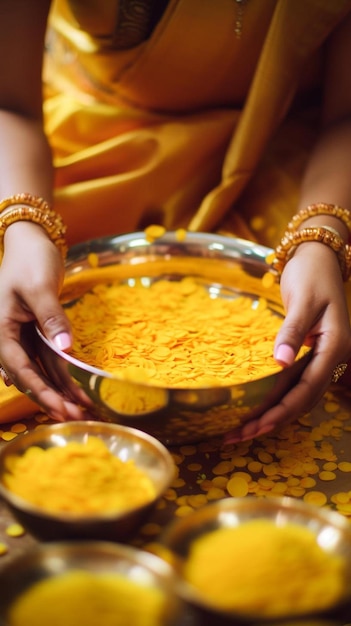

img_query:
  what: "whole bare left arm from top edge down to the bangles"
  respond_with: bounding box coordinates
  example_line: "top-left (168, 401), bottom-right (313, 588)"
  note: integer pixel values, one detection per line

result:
top-left (0, 0), bottom-right (53, 201)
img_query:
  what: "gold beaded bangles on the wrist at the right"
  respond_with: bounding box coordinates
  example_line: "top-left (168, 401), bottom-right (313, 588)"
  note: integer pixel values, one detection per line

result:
top-left (271, 203), bottom-right (351, 281)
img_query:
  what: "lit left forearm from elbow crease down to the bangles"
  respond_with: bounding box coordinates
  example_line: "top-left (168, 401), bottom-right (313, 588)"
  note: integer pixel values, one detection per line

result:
top-left (0, 110), bottom-right (53, 202)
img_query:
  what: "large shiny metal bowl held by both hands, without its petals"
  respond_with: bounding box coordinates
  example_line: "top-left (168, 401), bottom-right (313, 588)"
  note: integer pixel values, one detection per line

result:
top-left (37, 232), bottom-right (311, 445)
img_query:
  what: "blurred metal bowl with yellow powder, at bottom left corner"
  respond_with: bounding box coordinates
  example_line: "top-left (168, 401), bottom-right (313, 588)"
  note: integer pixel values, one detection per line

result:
top-left (0, 541), bottom-right (184, 626)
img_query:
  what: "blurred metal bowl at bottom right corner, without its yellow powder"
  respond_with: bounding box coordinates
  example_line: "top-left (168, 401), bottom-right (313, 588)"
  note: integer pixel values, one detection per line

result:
top-left (160, 496), bottom-right (351, 626)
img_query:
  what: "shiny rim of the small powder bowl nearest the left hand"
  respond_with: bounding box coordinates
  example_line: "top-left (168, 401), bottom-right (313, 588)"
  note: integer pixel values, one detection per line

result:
top-left (0, 420), bottom-right (176, 526)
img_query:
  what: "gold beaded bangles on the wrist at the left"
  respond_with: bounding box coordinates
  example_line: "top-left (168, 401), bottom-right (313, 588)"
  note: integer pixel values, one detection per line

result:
top-left (0, 193), bottom-right (67, 261)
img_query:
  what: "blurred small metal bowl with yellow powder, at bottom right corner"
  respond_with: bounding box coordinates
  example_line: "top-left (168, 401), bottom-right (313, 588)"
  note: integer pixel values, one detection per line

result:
top-left (161, 496), bottom-right (351, 626)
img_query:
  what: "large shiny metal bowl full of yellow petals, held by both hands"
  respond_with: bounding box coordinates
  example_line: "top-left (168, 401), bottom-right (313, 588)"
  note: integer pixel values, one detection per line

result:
top-left (37, 229), bottom-right (311, 445)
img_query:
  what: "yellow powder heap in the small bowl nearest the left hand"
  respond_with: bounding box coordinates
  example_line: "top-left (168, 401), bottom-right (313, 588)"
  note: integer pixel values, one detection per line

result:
top-left (4, 437), bottom-right (155, 515)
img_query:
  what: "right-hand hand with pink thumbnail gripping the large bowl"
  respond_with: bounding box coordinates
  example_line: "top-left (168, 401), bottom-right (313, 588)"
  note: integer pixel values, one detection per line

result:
top-left (225, 242), bottom-right (351, 443)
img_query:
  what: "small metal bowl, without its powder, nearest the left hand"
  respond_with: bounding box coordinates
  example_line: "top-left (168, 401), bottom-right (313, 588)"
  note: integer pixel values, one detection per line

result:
top-left (0, 421), bottom-right (175, 541)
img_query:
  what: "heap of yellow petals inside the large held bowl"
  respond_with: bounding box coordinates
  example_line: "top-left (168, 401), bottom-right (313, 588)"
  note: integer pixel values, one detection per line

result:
top-left (67, 278), bottom-right (288, 386)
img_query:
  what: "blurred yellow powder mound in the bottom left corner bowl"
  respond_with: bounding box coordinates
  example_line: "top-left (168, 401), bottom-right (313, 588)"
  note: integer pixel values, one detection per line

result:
top-left (7, 570), bottom-right (166, 626)
